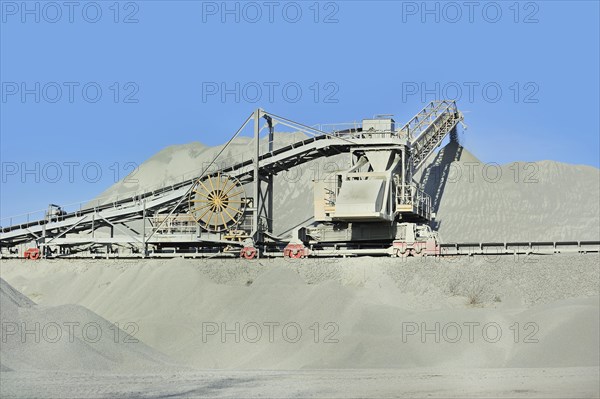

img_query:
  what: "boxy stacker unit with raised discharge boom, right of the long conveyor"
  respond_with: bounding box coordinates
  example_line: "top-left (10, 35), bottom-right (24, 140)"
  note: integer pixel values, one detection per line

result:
top-left (300, 109), bottom-right (450, 256)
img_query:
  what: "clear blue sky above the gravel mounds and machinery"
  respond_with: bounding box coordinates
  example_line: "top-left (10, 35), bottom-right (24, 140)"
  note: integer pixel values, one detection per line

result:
top-left (0, 0), bottom-right (600, 220)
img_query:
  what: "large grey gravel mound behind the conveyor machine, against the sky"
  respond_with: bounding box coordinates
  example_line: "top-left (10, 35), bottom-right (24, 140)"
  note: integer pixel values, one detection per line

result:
top-left (91, 133), bottom-right (600, 242)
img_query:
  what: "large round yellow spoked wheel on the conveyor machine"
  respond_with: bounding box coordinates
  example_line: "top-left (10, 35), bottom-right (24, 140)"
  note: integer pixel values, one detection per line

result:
top-left (190, 174), bottom-right (246, 233)
